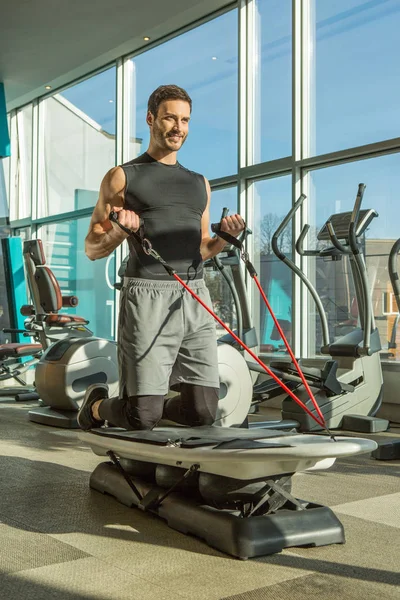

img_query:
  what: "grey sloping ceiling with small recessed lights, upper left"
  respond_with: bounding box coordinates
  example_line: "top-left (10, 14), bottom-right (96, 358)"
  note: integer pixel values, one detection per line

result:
top-left (0, 0), bottom-right (228, 110)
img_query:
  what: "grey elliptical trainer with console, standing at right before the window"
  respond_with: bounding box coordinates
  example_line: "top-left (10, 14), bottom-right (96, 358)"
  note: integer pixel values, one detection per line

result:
top-left (271, 184), bottom-right (389, 433)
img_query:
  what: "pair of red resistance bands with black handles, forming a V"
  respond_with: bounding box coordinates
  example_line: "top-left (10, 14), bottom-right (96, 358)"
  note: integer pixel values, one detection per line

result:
top-left (109, 212), bottom-right (330, 433)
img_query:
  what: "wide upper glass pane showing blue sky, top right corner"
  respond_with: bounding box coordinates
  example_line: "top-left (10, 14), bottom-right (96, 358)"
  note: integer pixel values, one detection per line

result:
top-left (310, 0), bottom-right (400, 155)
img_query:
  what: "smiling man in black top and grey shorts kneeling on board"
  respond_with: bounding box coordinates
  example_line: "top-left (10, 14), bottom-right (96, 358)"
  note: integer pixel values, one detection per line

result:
top-left (78, 85), bottom-right (244, 429)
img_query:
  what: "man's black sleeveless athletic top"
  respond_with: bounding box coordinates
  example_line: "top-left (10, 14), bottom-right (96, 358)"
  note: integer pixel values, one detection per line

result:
top-left (121, 152), bottom-right (207, 280)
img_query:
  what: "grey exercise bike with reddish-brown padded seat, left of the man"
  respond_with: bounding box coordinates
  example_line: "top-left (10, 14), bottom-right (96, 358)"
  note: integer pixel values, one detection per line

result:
top-left (23, 240), bottom-right (118, 428)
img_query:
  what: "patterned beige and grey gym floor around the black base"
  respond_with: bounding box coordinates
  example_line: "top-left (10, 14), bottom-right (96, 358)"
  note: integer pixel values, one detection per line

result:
top-left (0, 399), bottom-right (400, 600)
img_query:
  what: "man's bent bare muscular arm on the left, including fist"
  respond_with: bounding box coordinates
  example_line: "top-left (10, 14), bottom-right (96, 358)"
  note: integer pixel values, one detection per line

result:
top-left (85, 167), bottom-right (139, 260)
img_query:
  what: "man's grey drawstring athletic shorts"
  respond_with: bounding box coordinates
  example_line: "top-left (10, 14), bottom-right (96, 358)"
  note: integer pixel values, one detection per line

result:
top-left (118, 278), bottom-right (219, 396)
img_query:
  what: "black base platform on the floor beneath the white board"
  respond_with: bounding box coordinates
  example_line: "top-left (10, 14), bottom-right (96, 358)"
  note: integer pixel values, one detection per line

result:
top-left (90, 462), bottom-right (345, 560)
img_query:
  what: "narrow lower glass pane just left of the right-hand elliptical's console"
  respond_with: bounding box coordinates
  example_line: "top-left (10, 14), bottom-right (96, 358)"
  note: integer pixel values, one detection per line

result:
top-left (251, 175), bottom-right (292, 355)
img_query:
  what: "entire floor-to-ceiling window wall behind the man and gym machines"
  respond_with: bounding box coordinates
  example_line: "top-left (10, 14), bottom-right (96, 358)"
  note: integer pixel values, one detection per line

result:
top-left (5, 0), bottom-right (400, 360)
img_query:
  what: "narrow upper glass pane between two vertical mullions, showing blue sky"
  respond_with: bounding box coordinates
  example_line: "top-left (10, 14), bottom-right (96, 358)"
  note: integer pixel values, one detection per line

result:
top-left (255, 0), bottom-right (292, 164)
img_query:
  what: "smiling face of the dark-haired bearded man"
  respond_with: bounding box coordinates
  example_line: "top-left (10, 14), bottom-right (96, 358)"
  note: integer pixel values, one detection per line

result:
top-left (147, 100), bottom-right (190, 152)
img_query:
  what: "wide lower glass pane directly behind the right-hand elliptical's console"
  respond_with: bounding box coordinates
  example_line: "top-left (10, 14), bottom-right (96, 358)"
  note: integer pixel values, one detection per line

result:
top-left (309, 154), bottom-right (400, 360)
